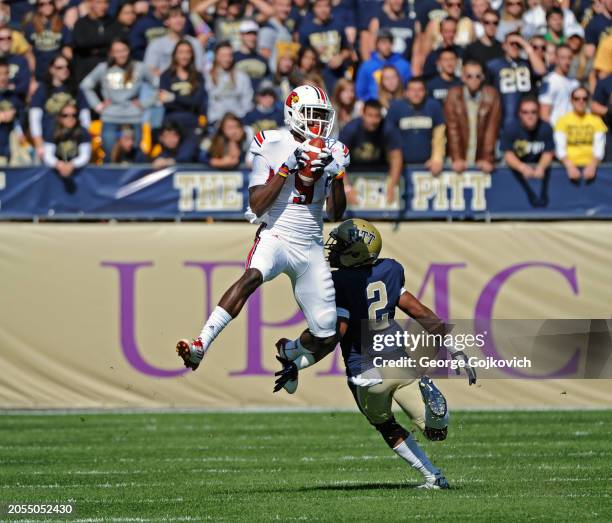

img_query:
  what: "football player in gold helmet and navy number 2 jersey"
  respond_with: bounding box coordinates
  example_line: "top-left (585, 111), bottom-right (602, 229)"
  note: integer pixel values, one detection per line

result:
top-left (274, 219), bottom-right (476, 489)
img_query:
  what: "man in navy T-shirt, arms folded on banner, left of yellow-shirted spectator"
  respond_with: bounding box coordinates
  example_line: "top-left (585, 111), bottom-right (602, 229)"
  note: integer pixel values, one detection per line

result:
top-left (501, 96), bottom-right (555, 178)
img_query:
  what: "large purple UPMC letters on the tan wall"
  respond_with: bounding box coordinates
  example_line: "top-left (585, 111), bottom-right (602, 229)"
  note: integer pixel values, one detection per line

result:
top-left (101, 260), bottom-right (586, 379)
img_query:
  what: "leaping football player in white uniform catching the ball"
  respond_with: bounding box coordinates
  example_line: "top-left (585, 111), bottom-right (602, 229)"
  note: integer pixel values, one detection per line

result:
top-left (176, 85), bottom-right (350, 392)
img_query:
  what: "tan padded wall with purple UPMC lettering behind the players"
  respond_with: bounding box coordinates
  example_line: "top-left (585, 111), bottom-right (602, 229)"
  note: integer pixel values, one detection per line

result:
top-left (0, 222), bottom-right (612, 408)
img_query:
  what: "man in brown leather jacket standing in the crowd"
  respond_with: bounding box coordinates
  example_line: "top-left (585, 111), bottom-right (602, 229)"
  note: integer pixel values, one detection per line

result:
top-left (444, 61), bottom-right (502, 173)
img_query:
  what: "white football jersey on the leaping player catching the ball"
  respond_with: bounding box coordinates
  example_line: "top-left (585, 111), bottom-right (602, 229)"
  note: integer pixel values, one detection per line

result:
top-left (246, 129), bottom-right (350, 240)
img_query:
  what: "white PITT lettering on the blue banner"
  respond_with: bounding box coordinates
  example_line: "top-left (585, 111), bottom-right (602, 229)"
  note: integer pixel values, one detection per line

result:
top-left (410, 171), bottom-right (491, 211)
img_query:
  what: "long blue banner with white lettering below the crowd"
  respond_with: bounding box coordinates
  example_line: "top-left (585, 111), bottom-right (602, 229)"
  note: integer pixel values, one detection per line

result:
top-left (0, 165), bottom-right (612, 220)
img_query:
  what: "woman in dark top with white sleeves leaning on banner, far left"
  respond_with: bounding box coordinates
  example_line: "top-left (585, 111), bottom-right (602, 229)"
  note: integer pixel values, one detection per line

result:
top-left (43, 101), bottom-right (91, 178)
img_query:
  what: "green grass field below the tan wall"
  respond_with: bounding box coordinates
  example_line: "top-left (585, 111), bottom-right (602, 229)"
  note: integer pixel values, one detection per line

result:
top-left (0, 411), bottom-right (612, 522)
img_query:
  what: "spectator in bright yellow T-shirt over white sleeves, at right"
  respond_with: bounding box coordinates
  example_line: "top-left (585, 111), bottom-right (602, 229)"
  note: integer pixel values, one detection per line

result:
top-left (555, 87), bottom-right (607, 181)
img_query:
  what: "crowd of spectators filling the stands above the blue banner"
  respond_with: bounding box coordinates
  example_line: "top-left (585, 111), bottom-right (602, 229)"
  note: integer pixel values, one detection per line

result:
top-left (0, 0), bottom-right (612, 194)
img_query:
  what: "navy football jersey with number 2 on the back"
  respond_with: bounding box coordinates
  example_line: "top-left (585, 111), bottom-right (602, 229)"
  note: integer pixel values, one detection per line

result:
top-left (332, 258), bottom-right (404, 376)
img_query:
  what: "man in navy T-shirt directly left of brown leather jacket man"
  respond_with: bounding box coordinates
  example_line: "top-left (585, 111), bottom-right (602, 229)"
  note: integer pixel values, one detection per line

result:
top-left (385, 78), bottom-right (445, 176)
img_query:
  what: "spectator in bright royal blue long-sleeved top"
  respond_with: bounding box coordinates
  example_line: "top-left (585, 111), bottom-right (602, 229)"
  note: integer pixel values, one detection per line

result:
top-left (355, 29), bottom-right (411, 100)
